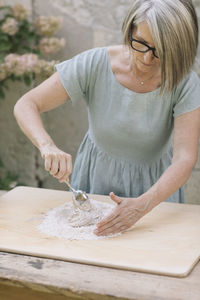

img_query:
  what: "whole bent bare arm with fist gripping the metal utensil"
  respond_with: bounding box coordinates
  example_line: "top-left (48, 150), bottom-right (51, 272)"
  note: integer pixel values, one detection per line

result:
top-left (14, 73), bottom-right (72, 182)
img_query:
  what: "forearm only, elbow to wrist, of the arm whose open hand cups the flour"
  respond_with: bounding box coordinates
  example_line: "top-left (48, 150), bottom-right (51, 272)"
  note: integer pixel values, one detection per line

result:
top-left (141, 160), bottom-right (194, 211)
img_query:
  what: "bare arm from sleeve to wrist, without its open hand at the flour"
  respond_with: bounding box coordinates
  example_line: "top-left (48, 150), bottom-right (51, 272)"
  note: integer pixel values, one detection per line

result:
top-left (143, 108), bottom-right (200, 207)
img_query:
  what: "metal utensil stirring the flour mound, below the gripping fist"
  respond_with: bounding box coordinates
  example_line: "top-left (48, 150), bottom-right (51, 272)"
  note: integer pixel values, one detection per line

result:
top-left (65, 181), bottom-right (91, 210)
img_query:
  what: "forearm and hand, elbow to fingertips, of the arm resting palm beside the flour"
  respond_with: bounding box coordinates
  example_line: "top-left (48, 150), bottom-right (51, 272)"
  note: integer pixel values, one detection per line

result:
top-left (94, 160), bottom-right (195, 235)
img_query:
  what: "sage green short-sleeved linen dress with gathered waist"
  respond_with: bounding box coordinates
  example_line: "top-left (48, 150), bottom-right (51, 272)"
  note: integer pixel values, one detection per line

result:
top-left (56, 47), bottom-right (200, 202)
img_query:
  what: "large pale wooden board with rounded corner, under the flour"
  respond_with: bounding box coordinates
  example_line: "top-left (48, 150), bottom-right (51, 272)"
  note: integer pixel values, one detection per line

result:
top-left (0, 187), bottom-right (200, 277)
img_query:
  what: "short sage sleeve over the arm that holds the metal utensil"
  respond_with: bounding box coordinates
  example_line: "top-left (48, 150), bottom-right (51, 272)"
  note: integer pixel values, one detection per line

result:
top-left (55, 48), bottom-right (100, 104)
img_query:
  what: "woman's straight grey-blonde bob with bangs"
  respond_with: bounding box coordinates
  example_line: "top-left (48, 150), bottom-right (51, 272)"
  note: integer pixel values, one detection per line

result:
top-left (122, 0), bottom-right (198, 93)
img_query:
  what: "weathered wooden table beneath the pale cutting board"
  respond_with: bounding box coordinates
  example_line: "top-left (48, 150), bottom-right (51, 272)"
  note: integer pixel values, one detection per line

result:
top-left (0, 252), bottom-right (200, 300)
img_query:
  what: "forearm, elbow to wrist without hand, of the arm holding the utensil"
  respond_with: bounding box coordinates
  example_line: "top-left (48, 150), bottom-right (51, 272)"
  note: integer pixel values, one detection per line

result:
top-left (14, 95), bottom-right (54, 149)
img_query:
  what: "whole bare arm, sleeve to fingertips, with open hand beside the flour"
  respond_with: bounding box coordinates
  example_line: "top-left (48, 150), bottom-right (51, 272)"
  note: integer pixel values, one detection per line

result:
top-left (95, 108), bottom-right (200, 235)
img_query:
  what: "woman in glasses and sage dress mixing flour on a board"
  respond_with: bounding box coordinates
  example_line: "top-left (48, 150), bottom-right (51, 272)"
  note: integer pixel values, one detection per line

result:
top-left (14, 0), bottom-right (200, 235)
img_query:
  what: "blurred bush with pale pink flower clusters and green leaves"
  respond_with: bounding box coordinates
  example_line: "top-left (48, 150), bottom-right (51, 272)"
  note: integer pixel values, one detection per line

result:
top-left (0, 4), bottom-right (65, 98)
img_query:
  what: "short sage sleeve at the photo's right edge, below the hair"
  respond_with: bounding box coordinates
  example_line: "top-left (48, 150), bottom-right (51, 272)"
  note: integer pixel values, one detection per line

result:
top-left (173, 71), bottom-right (200, 118)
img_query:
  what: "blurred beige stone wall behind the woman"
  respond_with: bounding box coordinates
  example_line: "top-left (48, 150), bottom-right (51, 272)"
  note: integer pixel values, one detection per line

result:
top-left (0, 0), bottom-right (200, 204)
